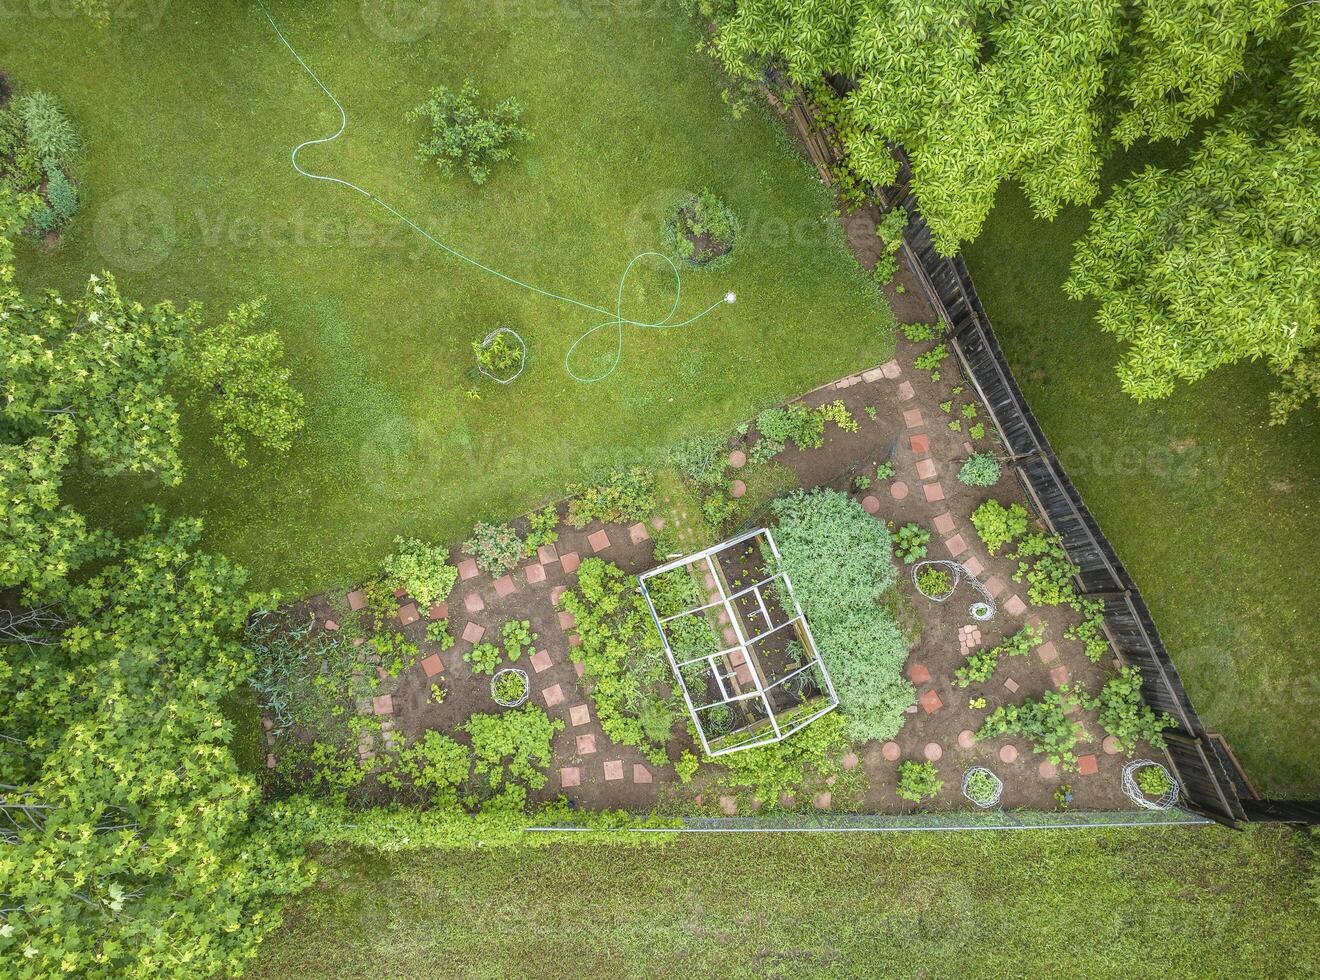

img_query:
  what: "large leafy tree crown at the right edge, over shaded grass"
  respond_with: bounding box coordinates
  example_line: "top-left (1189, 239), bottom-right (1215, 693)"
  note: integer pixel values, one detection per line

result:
top-left (1065, 5), bottom-right (1320, 423)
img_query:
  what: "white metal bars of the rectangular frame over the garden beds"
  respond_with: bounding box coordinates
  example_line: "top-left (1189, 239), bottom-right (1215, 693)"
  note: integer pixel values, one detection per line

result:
top-left (638, 528), bottom-right (838, 757)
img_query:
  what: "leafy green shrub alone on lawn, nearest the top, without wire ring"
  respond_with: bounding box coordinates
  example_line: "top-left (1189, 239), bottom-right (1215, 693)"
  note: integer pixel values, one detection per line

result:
top-left (408, 79), bottom-right (531, 184)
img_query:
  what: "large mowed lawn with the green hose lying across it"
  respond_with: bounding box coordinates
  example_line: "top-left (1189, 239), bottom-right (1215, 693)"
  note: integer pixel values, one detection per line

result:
top-left (0, 1), bottom-right (892, 593)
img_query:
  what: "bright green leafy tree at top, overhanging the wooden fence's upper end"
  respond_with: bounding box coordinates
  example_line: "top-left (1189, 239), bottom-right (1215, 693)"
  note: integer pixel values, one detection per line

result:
top-left (713, 0), bottom-right (1284, 254)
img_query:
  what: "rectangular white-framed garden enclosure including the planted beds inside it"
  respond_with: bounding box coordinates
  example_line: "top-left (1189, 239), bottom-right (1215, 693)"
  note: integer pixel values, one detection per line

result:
top-left (639, 527), bottom-right (838, 757)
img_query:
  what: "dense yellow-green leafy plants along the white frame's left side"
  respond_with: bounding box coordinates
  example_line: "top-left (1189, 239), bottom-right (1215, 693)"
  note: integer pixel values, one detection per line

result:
top-left (560, 557), bottom-right (681, 766)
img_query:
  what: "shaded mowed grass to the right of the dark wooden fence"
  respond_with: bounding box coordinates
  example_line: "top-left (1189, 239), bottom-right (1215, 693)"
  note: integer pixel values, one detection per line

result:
top-left (965, 180), bottom-right (1320, 796)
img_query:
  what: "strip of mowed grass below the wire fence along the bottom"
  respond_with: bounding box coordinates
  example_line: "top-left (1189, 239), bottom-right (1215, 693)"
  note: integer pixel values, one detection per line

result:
top-left (251, 828), bottom-right (1320, 980)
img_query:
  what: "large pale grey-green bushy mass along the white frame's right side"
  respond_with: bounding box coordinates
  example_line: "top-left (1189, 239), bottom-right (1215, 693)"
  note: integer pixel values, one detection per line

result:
top-left (772, 489), bottom-right (913, 741)
